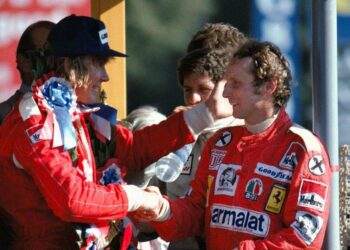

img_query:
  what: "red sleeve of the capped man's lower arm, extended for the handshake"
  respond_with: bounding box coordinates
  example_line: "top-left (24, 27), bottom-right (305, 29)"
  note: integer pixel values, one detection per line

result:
top-left (13, 116), bottom-right (128, 223)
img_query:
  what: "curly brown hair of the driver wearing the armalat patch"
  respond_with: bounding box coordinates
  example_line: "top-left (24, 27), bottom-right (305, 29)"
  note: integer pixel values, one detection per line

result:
top-left (234, 40), bottom-right (292, 108)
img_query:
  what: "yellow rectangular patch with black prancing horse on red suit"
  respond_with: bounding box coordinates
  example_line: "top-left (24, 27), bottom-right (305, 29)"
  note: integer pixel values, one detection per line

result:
top-left (265, 184), bottom-right (287, 214)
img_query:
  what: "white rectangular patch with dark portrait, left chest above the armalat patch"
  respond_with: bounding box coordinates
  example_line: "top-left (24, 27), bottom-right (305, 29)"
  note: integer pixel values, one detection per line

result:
top-left (214, 164), bottom-right (242, 196)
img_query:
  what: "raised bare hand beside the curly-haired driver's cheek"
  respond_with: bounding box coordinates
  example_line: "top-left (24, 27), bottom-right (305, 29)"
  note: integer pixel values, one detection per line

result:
top-left (205, 79), bottom-right (233, 120)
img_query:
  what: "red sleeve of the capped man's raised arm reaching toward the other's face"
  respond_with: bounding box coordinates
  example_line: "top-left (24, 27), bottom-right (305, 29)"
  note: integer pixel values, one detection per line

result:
top-left (113, 112), bottom-right (194, 170)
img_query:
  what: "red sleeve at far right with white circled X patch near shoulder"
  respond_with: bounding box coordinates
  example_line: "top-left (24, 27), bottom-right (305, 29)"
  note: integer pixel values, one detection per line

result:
top-left (239, 138), bottom-right (332, 250)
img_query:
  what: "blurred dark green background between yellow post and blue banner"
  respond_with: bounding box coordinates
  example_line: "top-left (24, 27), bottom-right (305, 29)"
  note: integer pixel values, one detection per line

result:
top-left (125, 0), bottom-right (249, 115)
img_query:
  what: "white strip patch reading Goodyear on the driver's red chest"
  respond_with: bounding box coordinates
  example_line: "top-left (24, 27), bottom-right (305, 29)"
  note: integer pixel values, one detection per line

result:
top-left (255, 162), bottom-right (293, 183)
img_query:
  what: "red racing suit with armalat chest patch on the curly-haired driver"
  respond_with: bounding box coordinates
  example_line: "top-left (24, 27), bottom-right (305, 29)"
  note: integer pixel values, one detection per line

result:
top-left (152, 109), bottom-right (331, 250)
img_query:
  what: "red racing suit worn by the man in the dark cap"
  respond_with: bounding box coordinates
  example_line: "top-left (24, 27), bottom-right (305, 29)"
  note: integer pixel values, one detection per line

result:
top-left (0, 77), bottom-right (194, 249)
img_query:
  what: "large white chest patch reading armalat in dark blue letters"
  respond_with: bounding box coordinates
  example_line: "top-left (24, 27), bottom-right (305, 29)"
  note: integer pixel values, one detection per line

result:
top-left (210, 204), bottom-right (270, 237)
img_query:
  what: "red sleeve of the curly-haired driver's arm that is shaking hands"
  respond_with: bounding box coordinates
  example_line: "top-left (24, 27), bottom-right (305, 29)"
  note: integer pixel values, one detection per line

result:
top-left (151, 138), bottom-right (210, 241)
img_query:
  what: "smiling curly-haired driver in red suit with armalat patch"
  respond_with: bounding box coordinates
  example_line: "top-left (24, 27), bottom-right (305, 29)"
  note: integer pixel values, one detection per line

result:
top-left (136, 41), bottom-right (331, 250)
